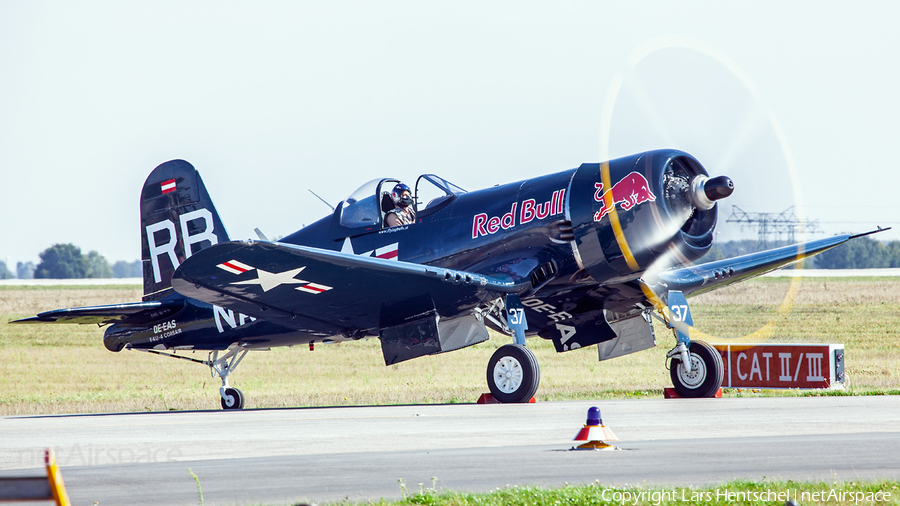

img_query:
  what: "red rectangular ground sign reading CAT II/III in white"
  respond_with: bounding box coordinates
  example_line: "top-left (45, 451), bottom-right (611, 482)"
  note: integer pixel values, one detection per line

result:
top-left (713, 344), bottom-right (844, 388)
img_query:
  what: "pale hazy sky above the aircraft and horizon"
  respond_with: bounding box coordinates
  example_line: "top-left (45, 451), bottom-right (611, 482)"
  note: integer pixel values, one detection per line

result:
top-left (0, 0), bottom-right (900, 267)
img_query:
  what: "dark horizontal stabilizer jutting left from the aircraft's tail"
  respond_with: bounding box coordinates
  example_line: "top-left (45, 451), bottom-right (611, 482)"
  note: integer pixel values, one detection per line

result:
top-left (10, 301), bottom-right (183, 324)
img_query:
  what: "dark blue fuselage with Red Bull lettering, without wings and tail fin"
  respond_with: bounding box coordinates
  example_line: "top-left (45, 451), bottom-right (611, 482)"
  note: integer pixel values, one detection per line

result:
top-left (106, 150), bottom-right (715, 349)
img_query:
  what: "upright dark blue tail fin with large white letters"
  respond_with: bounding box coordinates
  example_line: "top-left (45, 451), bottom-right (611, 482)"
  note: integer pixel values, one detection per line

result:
top-left (141, 160), bottom-right (228, 300)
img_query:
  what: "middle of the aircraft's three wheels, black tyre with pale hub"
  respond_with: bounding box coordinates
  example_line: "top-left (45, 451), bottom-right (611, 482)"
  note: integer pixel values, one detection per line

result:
top-left (487, 344), bottom-right (541, 403)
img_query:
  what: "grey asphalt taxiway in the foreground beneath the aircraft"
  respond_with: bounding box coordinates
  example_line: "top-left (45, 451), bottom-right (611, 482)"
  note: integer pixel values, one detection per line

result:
top-left (0, 396), bottom-right (900, 505)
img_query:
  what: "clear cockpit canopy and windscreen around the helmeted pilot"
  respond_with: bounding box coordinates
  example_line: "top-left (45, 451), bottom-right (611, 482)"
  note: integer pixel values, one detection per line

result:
top-left (340, 174), bottom-right (466, 229)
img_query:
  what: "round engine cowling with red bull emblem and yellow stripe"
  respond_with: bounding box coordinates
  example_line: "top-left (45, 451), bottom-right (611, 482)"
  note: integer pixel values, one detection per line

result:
top-left (568, 150), bottom-right (734, 283)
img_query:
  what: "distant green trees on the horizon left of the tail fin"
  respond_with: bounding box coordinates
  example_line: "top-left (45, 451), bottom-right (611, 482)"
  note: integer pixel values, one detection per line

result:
top-left (0, 244), bottom-right (143, 279)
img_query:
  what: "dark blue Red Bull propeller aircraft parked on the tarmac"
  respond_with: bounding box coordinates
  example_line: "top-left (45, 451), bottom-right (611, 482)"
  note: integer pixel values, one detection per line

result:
top-left (15, 150), bottom-right (880, 409)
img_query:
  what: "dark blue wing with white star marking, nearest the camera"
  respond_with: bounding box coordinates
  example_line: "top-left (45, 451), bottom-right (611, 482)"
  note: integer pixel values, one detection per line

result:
top-left (172, 241), bottom-right (521, 335)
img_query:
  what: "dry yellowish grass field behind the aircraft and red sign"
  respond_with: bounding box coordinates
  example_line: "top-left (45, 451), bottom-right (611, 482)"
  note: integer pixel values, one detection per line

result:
top-left (0, 278), bottom-right (900, 415)
